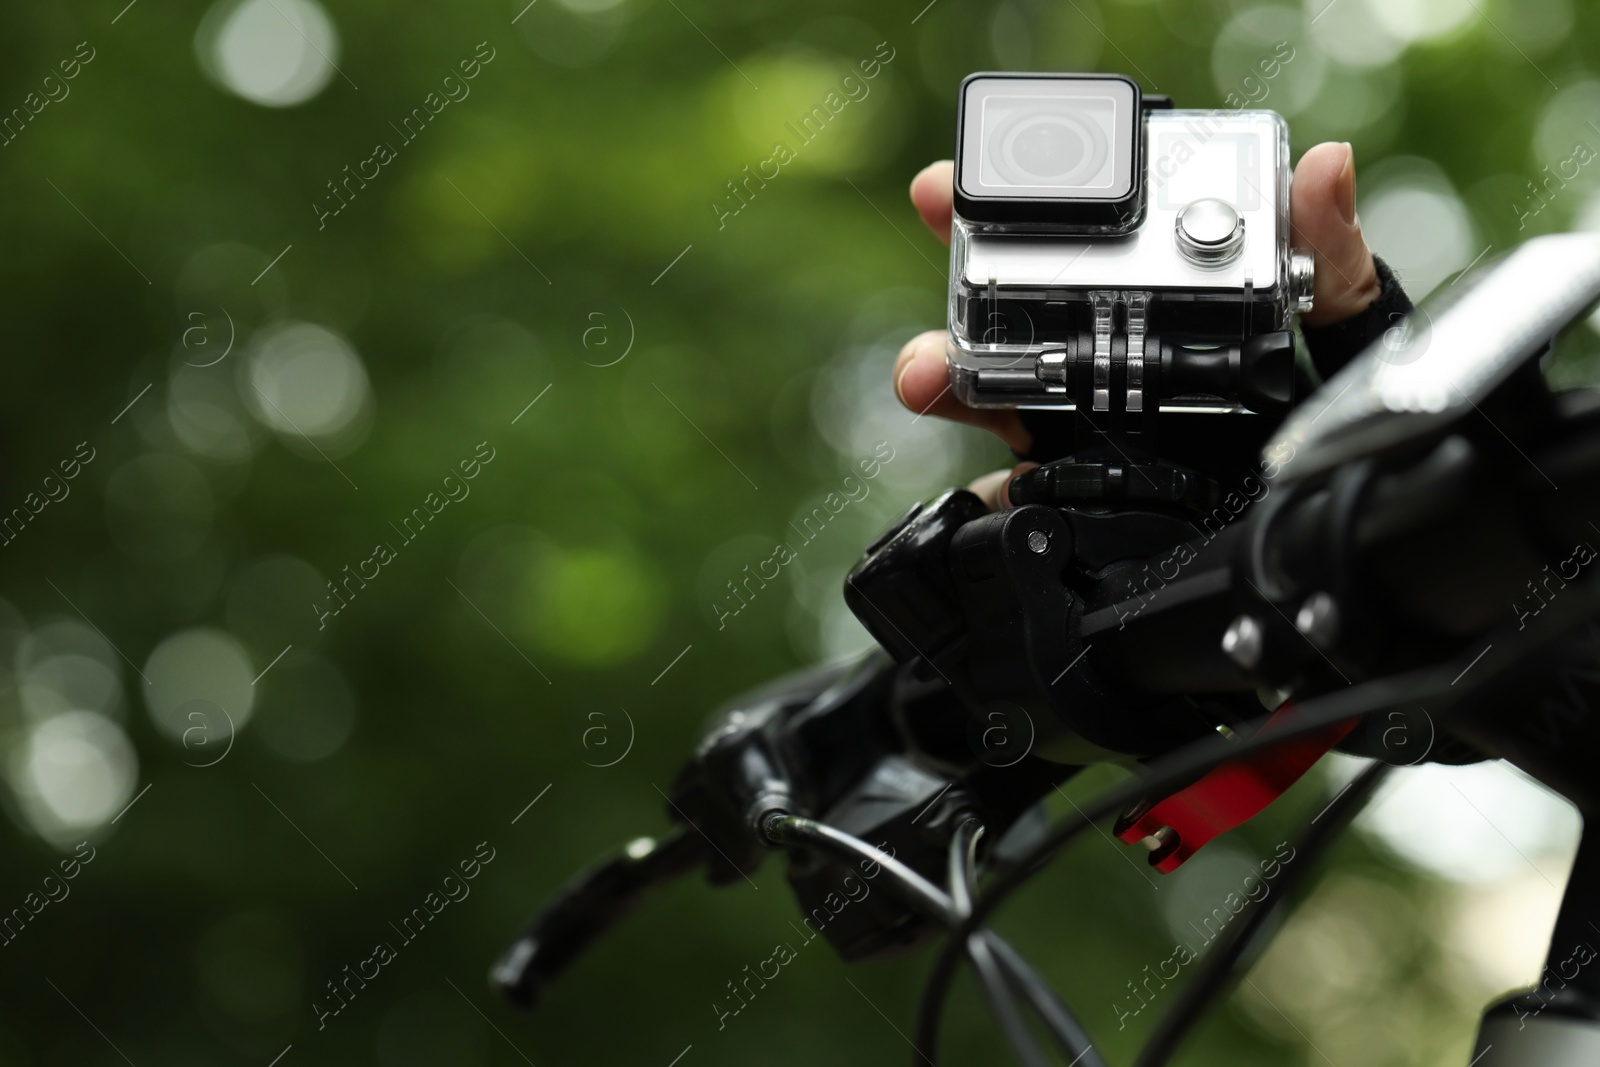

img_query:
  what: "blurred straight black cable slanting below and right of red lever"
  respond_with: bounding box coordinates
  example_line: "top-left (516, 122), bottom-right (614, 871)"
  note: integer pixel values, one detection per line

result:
top-left (1134, 763), bottom-right (1394, 1067)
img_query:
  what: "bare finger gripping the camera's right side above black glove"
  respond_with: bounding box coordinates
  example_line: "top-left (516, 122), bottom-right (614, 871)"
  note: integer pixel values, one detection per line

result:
top-left (1290, 142), bottom-right (1379, 326)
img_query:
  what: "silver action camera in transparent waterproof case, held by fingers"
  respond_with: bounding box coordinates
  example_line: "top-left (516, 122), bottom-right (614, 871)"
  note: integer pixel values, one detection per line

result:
top-left (949, 74), bottom-right (1314, 413)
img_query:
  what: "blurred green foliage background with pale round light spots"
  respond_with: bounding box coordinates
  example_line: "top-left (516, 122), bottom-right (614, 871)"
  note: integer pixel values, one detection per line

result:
top-left (0, 0), bottom-right (1600, 1067)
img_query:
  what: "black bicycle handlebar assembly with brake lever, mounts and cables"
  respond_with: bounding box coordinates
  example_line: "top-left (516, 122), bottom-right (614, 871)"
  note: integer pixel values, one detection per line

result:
top-left (493, 238), bottom-right (1600, 1062)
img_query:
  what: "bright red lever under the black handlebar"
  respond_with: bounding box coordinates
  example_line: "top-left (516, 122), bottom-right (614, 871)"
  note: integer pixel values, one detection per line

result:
top-left (1115, 702), bottom-right (1357, 875)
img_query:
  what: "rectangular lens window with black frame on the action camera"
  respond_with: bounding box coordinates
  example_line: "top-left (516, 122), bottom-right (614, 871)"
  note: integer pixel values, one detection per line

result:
top-left (960, 77), bottom-right (1138, 200)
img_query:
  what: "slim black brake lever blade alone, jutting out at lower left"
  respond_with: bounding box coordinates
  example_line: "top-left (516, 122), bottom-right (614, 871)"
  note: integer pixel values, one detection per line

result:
top-left (490, 827), bottom-right (707, 1011)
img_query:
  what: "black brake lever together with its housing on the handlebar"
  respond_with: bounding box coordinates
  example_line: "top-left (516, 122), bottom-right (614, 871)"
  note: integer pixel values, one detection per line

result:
top-left (490, 654), bottom-right (1075, 1009)
